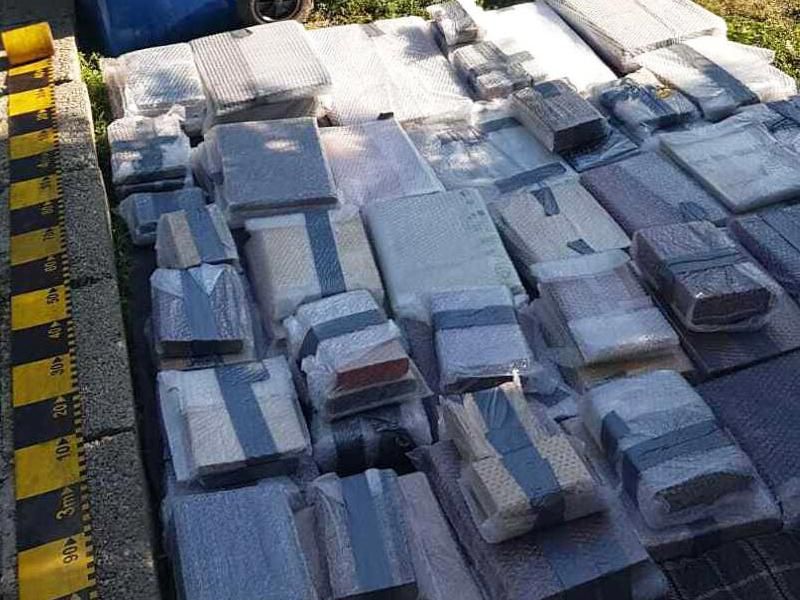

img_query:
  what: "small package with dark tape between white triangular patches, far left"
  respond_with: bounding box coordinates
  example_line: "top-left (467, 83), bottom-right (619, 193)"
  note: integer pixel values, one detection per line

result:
top-left (150, 264), bottom-right (244, 358)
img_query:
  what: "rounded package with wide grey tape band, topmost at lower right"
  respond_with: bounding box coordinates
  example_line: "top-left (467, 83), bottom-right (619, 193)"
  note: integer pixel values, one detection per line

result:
top-left (580, 371), bottom-right (768, 529)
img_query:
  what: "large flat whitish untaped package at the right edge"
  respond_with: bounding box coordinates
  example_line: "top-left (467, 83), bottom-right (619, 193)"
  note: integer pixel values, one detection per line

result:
top-left (661, 122), bottom-right (800, 213)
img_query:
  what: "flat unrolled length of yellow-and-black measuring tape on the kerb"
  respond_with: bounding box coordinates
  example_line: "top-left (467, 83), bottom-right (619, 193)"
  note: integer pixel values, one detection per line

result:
top-left (7, 58), bottom-right (97, 600)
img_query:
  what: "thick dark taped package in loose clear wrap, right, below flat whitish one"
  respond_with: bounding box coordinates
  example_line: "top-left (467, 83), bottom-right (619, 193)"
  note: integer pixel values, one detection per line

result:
top-left (632, 222), bottom-right (780, 332)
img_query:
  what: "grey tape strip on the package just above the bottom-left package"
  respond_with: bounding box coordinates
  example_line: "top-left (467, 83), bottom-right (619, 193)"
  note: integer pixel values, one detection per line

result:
top-left (215, 365), bottom-right (278, 459)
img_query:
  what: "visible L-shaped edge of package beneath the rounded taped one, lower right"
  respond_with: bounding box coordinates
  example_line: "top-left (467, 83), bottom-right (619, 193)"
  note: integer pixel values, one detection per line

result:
top-left (561, 419), bottom-right (782, 562)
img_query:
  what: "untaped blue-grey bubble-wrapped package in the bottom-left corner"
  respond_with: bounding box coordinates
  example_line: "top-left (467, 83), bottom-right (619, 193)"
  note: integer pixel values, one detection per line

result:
top-left (169, 484), bottom-right (319, 600)
